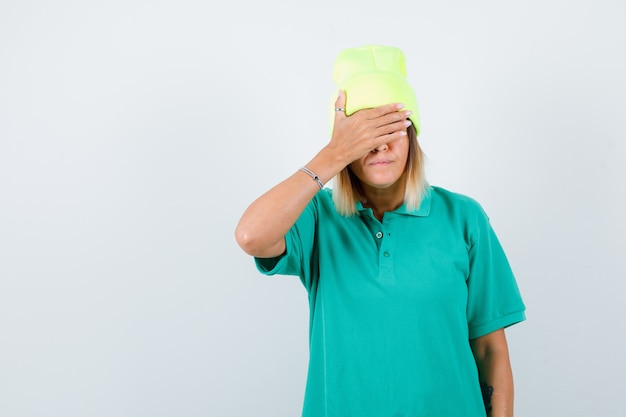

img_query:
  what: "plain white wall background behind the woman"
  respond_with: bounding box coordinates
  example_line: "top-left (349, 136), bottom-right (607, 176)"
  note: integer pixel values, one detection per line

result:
top-left (0, 0), bottom-right (626, 417)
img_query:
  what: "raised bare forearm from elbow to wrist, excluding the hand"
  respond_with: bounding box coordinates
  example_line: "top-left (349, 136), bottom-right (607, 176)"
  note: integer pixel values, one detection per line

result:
top-left (235, 146), bottom-right (346, 258)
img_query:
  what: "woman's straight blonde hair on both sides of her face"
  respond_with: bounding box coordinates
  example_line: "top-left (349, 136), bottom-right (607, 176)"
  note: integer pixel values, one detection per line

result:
top-left (333, 126), bottom-right (427, 216)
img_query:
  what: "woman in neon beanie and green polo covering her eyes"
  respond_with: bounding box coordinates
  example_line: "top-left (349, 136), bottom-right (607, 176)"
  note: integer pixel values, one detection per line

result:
top-left (236, 45), bottom-right (525, 417)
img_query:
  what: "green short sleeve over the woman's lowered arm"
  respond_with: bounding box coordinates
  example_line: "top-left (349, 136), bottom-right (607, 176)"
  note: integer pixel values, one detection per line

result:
top-left (467, 207), bottom-right (526, 339)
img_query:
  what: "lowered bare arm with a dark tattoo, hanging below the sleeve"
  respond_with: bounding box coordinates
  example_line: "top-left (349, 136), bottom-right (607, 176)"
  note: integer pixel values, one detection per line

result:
top-left (472, 330), bottom-right (514, 417)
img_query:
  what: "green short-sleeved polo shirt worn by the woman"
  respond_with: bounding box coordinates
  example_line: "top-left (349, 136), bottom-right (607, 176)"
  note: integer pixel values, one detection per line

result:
top-left (256, 187), bottom-right (525, 417)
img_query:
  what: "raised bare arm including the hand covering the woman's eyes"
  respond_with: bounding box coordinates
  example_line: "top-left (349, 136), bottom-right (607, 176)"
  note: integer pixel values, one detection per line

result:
top-left (235, 92), bottom-right (410, 258)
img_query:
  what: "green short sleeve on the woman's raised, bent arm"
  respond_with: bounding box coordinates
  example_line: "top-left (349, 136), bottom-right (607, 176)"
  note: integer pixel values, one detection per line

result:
top-left (254, 191), bottom-right (318, 290)
